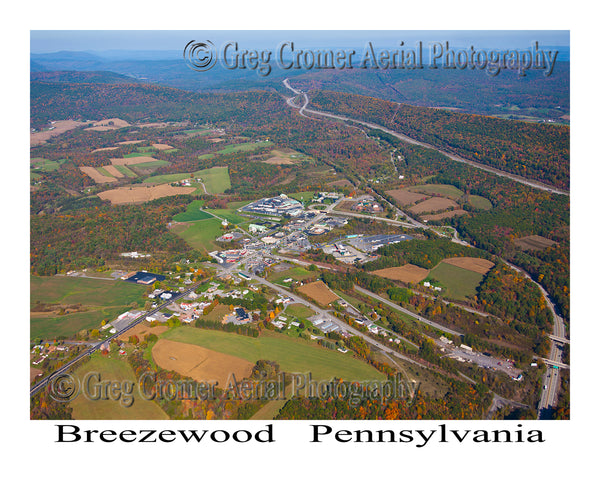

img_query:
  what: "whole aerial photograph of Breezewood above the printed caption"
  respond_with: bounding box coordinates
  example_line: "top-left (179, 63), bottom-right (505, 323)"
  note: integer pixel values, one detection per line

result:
top-left (29, 30), bottom-right (572, 424)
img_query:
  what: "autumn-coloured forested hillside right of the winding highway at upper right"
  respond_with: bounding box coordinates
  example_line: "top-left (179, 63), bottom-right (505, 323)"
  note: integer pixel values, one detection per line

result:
top-left (311, 91), bottom-right (570, 189)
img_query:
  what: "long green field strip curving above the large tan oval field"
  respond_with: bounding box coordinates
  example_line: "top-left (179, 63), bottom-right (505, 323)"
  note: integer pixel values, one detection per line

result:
top-left (161, 327), bottom-right (385, 381)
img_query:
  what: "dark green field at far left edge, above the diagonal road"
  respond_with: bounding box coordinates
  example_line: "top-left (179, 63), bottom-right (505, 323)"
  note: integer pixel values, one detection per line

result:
top-left (30, 276), bottom-right (146, 338)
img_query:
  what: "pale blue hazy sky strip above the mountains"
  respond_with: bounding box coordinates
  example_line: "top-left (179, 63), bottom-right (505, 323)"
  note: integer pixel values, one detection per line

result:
top-left (31, 30), bottom-right (570, 53)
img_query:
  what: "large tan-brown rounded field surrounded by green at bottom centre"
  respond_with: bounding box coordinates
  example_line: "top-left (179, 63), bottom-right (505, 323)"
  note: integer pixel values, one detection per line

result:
top-left (152, 338), bottom-right (253, 385)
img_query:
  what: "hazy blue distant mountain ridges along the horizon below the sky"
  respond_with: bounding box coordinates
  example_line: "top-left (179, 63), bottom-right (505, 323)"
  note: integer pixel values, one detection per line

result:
top-left (30, 51), bottom-right (570, 123)
